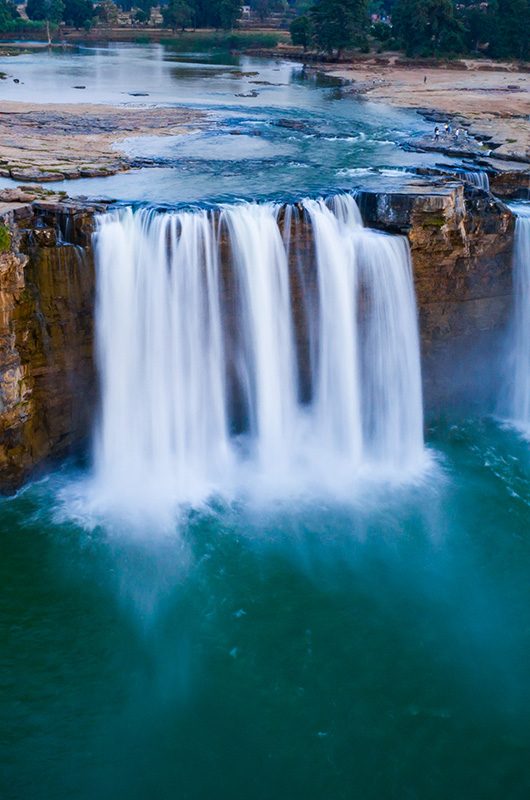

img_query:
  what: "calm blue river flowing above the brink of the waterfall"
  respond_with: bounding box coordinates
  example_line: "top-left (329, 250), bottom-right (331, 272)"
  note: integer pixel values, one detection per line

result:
top-left (0, 44), bottom-right (460, 204)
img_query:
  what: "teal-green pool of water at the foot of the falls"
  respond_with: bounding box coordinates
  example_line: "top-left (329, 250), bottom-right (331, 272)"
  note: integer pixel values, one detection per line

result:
top-left (0, 420), bottom-right (530, 800)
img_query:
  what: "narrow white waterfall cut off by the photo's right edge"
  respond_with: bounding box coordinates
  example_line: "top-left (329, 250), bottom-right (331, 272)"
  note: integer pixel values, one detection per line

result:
top-left (511, 204), bottom-right (530, 434)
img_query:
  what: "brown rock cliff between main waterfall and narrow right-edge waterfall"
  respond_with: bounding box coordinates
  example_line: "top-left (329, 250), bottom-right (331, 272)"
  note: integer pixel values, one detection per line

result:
top-left (361, 182), bottom-right (514, 409)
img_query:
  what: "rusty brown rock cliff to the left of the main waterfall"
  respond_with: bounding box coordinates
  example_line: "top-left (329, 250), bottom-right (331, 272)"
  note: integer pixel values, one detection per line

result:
top-left (0, 203), bottom-right (95, 490)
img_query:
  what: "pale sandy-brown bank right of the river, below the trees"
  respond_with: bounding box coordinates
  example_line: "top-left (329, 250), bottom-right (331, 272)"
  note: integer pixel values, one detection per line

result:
top-left (319, 56), bottom-right (530, 162)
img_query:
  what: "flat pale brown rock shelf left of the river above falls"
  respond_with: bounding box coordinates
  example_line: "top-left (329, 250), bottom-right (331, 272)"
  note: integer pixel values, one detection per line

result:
top-left (0, 102), bottom-right (206, 181)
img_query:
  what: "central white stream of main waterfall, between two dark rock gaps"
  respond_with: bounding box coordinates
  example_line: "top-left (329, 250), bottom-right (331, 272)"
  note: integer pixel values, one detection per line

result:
top-left (221, 204), bottom-right (296, 469)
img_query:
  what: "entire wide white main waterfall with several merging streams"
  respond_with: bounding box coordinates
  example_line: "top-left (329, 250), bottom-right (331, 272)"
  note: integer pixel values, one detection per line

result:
top-left (95, 195), bottom-right (424, 507)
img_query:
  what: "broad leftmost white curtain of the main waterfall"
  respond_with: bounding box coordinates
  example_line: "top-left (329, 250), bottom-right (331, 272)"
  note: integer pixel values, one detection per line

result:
top-left (96, 210), bottom-right (230, 500)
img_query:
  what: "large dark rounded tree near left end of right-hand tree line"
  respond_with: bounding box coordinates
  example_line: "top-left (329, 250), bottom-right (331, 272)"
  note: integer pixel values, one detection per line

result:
top-left (310, 0), bottom-right (368, 56)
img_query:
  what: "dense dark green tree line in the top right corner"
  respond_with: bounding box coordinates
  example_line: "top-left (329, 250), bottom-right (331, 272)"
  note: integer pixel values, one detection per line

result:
top-left (291, 0), bottom-right (530, 60)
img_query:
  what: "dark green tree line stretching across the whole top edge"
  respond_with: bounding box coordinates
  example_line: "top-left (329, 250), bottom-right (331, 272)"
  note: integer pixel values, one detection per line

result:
top-left (0, 0), bottom-right (530, 60)
